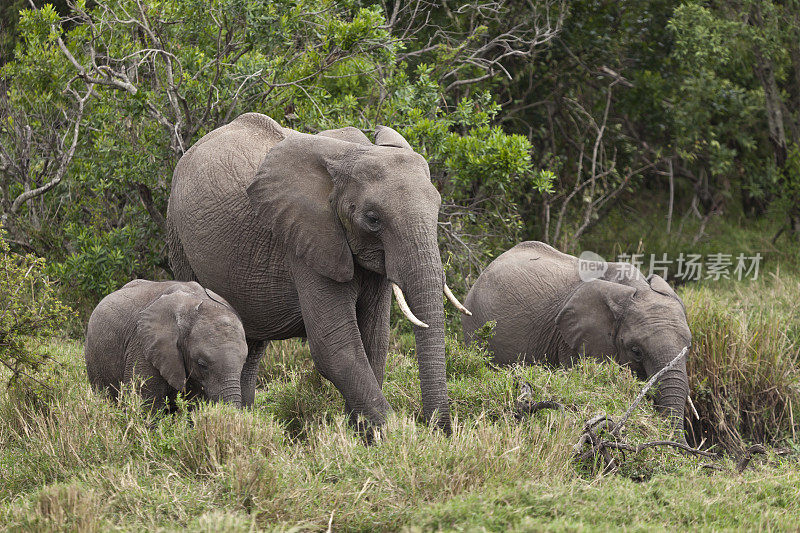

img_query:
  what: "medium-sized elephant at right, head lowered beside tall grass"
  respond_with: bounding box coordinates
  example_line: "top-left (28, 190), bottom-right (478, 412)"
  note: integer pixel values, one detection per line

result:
top-left (462, 241), bottom-right (692, 436)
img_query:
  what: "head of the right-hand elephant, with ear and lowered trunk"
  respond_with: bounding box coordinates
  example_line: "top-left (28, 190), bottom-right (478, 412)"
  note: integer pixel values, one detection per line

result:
top-left (556, 275), bottom-right (692, 436)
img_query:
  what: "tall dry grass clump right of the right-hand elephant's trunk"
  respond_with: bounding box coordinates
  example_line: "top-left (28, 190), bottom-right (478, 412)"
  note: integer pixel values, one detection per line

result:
top-left (682, 282), bottom-right (800, 452)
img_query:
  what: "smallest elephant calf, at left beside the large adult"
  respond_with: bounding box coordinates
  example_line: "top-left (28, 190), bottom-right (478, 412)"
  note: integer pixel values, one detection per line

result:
top-left (85, 279), bottom-right (247, 408)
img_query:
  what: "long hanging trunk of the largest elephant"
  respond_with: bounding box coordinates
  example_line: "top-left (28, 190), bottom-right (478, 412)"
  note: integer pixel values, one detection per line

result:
top-left (391, 232), bottom-right (452, 434)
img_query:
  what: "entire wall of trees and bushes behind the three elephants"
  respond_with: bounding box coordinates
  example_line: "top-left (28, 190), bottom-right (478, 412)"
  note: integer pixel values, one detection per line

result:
top-left (0, 0), bottom-right (800, 308)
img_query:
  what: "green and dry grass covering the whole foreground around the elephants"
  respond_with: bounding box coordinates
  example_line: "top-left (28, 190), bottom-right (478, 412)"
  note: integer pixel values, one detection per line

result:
top-left (0, 266), bottom-right (800, 531)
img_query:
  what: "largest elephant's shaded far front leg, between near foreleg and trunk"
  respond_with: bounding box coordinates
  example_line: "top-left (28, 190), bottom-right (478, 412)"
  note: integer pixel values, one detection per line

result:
top-left (356, 272), bottom-right (392, 387)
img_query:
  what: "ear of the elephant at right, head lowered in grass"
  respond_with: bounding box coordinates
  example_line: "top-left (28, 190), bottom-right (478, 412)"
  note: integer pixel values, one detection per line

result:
top-left (556, 279), bottom-right (636, 356)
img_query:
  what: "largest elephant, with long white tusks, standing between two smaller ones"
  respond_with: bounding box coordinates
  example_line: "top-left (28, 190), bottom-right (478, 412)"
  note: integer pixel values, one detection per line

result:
top-left (167, 113), bottom-right (450, 431)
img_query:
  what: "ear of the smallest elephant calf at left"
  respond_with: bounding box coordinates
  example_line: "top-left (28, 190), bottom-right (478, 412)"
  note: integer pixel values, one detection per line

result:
top-left (137, 291), bottom-right (202, 390)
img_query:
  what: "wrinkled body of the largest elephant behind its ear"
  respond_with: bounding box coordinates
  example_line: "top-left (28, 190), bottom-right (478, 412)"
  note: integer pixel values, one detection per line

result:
top-left (167, 113), bottom-right (302, 337)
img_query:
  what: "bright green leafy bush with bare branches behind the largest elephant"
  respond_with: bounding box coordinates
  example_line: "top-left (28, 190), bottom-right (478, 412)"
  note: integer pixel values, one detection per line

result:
top-left (0, 0), bottom-right (548, 309)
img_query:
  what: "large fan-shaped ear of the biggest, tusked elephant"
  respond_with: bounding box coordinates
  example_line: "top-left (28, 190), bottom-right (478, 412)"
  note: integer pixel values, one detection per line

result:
top-left (247, 133), bottom-right (356, 282)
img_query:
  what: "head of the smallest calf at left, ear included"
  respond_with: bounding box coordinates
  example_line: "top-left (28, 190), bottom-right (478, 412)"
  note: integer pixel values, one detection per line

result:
top-left (137, 290), bottom-right (247, 407)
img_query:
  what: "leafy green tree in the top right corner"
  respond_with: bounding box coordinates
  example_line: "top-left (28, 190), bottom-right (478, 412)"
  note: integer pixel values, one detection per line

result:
top-left (670, 0), bottom-right (800, 234)
